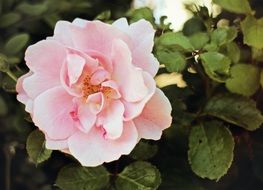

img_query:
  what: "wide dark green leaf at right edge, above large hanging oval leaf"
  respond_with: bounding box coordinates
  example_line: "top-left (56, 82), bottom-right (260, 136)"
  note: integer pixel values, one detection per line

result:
top-left (204, 94), bottom-right (263, 131)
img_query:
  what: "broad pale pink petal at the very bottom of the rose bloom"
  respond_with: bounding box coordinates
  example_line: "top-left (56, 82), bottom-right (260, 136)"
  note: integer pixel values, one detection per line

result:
top-left (68, 122), bottom-right (138, 166)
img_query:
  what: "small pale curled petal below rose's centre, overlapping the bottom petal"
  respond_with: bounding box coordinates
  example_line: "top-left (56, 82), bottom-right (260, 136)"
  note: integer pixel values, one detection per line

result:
top-left (97, 100), bottom-right (124, 139)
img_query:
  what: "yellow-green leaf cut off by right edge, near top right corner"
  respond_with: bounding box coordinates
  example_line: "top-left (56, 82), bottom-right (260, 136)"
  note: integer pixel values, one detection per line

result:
top-left (241, 16), bottom-right (263, 49)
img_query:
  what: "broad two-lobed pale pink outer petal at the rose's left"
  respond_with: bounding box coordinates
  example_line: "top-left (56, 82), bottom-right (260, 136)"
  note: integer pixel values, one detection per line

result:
top-left (22, 40), bottom-right (66, 99)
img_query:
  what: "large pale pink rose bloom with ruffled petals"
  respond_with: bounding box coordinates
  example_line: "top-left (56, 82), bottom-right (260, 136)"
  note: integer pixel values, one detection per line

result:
top-left (16, 18), bottom-right (172, 166)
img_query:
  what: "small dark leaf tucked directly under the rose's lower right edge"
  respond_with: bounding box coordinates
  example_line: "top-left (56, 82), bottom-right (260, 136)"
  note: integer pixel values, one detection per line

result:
top-left (130, 141), bottom-right (158, 160)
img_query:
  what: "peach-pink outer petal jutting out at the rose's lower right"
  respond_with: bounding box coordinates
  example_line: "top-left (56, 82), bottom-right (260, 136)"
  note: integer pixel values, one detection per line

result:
top-left (133, 88), bottom-right (172, 140)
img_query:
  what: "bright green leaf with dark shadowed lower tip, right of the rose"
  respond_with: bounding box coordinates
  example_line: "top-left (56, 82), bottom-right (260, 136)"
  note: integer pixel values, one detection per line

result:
top-left (200, 52), bottom-right (231, 82)
